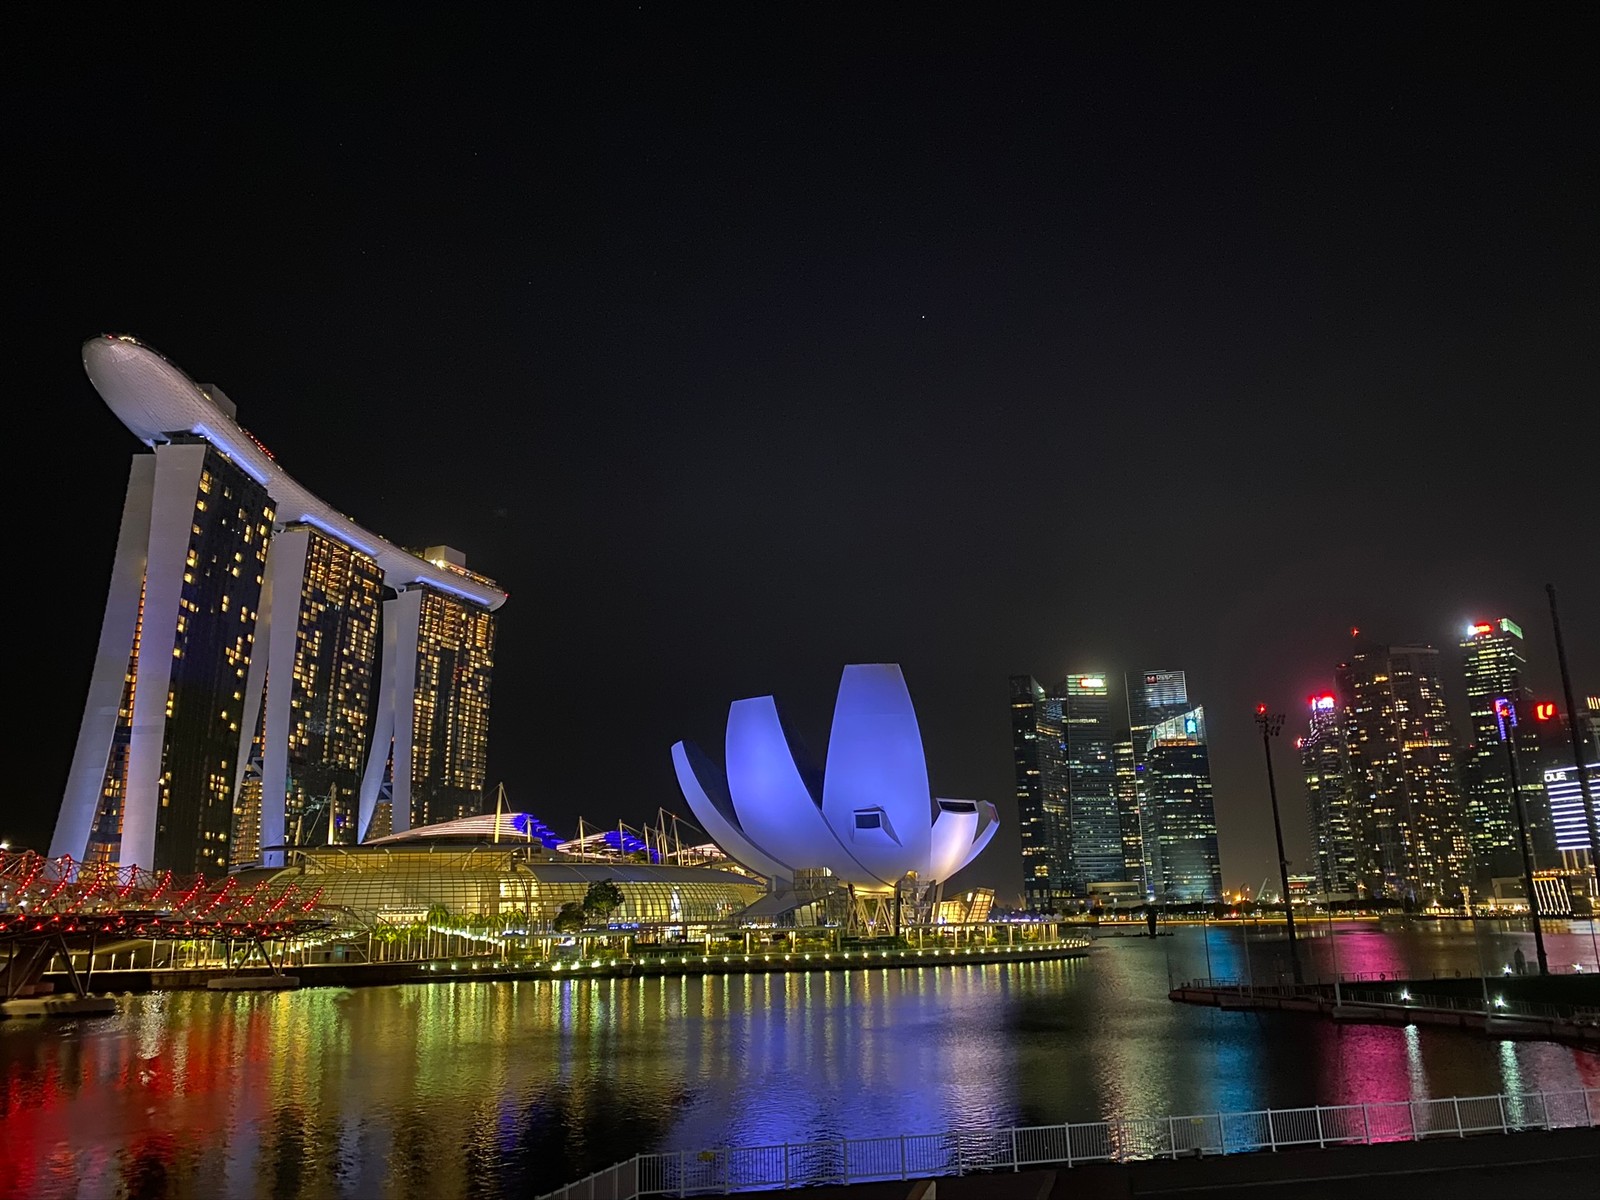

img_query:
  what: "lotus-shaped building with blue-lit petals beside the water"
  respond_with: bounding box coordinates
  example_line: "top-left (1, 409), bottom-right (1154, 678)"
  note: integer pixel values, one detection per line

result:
top-left (672, 662), bottom-right (1000, 891)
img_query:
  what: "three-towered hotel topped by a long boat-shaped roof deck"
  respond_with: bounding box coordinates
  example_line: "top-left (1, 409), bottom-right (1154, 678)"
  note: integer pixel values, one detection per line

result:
top-left (50, 336), bottom-right (506, 874)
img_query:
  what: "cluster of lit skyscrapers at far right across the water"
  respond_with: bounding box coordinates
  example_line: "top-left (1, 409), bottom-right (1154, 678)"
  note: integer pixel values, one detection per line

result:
top-left (1294, 616), bottom-right (1600, 912)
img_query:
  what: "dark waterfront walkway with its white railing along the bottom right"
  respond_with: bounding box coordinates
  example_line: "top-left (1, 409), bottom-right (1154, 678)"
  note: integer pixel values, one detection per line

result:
top-left (546, 1088), bottom-right (1600, 1200)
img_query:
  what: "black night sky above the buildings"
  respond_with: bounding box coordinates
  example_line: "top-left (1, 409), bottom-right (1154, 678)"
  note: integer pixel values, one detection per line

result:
top-left (0, 5), bottom-right (1600, 896)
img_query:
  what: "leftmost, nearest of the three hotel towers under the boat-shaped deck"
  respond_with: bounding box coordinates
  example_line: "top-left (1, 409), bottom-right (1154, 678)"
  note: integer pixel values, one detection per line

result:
top-left (53, 432), bottom-right (274, 872)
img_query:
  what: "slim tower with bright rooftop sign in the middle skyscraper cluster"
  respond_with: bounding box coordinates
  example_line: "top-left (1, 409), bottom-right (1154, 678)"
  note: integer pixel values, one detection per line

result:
top-left (1059, 672), bottom-right (1126, 896)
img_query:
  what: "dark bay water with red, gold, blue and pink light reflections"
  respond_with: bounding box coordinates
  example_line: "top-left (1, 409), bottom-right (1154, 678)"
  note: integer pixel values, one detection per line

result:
top-left (0, 923), bottom-right (1600, 1200)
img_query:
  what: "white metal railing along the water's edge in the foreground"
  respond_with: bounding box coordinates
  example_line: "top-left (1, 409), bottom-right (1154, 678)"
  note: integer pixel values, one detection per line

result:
top-left (546, 1088), bottom-right (1600, 1200)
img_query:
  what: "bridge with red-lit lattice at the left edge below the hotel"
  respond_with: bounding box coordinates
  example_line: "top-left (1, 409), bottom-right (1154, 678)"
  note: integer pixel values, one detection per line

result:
top-left (0, 850), bottom-right (334, 1000)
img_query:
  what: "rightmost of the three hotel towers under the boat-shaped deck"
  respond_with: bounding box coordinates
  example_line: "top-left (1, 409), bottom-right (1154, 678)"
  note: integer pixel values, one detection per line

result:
top-left (360, 546), bottom-right (494, 832)
